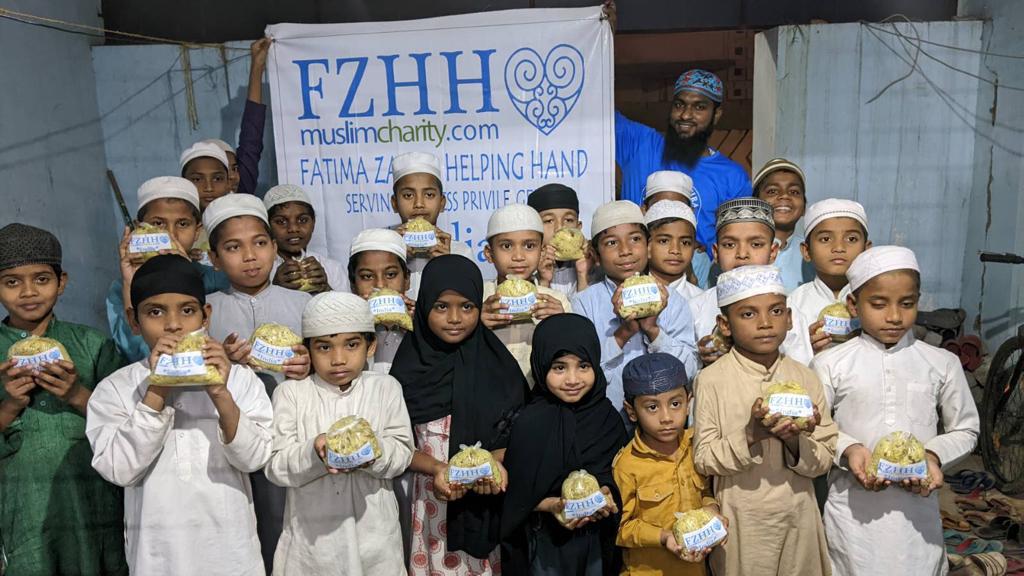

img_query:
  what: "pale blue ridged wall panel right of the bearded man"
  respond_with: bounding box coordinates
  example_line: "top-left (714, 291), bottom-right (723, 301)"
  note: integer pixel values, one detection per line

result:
top-left (754, 22), bottom-right (983, 310)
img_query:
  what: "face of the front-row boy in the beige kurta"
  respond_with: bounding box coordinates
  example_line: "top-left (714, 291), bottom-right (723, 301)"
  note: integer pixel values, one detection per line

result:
top-left (718, 294), bottom-right (793, 356)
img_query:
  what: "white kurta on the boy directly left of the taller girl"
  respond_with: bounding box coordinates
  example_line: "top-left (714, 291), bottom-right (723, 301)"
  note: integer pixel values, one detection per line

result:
top-left (266, 372), bottom-right (414, 576)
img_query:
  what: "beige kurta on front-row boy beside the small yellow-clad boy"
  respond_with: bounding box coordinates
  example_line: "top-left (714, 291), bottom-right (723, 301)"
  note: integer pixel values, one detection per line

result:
top-left (693, 348), bottom-right (839, 576)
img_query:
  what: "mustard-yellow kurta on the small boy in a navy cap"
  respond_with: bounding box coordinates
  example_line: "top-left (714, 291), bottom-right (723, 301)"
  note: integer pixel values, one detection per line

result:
top-left (612, 429), bottom-right (715, 576)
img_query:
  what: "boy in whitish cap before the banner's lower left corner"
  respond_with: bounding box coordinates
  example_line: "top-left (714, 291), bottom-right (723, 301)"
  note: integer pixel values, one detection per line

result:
top-left (263, 184), bottom-right (348, 294)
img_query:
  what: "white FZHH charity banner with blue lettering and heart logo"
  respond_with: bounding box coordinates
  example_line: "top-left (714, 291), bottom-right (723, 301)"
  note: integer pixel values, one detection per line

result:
top-left (266, 7), bottom-right (614, 275)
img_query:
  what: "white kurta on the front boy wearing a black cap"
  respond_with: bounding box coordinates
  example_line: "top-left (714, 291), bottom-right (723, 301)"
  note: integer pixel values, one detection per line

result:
top-left (86, 360), bottom-right (272, 576)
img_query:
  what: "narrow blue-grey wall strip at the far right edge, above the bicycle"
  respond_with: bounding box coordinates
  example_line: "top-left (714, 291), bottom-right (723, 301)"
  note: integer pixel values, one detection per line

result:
top-left (958, 0), bottom-right (1024, 342)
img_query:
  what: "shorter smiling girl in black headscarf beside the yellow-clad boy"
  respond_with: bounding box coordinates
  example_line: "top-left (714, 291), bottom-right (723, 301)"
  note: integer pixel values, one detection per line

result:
top-left (501, 314), bottom-right (627, 576)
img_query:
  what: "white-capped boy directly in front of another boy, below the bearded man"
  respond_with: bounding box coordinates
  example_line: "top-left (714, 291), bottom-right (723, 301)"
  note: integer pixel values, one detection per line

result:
top-left (643, 200), bottom-right (702, 301)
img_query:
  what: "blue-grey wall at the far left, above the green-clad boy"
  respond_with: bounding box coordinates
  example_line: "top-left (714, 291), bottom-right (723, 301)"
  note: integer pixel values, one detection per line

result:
top-left (0, 0), bottom-right (118, 330)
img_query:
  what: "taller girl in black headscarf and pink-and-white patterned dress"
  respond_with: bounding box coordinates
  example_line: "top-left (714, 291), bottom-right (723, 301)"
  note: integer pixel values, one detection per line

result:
top-left (391, 255), bottom-right (528, 575)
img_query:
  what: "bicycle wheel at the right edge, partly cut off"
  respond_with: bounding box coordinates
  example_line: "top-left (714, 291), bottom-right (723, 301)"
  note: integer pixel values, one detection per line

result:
top-left (980, 337), bottom-right (1024, 492)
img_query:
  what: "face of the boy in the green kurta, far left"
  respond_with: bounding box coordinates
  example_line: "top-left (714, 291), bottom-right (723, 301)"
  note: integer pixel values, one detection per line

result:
top-left (0, 264), bottom-right (68, 328)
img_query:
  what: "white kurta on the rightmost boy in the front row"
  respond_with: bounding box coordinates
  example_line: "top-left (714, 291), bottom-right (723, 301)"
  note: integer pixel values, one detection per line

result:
top-left (813, 332), bottom-right (980, 575)
